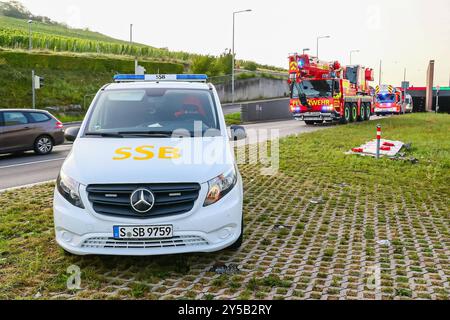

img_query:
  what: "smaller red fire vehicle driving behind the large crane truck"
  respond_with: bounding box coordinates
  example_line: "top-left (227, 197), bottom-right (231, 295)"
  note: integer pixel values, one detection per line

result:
top-left (375, 85), bottom-right (405, 115)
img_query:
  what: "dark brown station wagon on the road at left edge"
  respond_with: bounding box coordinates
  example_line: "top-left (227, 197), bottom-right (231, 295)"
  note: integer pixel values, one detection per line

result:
top-left (0, 109), bottom-right (64, 155)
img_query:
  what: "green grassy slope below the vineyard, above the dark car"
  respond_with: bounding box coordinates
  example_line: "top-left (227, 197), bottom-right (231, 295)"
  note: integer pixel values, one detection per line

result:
top-left (0, 50), bottom-right (184, 108)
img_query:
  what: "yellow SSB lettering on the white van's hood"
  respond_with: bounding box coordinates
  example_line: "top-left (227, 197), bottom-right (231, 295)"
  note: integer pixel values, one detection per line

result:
top-left (113, 146), bottom-right (181, 161)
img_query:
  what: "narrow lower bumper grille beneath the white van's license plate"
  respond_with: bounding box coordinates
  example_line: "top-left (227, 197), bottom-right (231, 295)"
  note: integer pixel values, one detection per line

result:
top-left (82, 236), bottom-right (209, 249)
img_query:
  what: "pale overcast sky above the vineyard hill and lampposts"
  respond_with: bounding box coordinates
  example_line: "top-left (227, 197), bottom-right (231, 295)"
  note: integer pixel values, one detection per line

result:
top-left (20, 0), bottom-right (450, 86)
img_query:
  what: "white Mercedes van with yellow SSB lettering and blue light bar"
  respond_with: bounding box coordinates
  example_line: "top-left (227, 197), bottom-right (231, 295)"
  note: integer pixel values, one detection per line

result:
top-left (54, 75), bottom-right (246, 256)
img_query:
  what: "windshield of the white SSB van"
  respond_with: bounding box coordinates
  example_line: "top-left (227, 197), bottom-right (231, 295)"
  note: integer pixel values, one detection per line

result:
top-left (85, 88), bottom-right (220, 136)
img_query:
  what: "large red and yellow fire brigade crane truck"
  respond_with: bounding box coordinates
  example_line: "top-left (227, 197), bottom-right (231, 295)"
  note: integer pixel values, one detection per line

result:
top-left (288, 54), bottom-right (374, 125)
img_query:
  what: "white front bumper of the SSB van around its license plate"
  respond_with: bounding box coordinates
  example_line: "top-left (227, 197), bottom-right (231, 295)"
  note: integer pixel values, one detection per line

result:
top-left (53, 180), bottom-right (243, 256)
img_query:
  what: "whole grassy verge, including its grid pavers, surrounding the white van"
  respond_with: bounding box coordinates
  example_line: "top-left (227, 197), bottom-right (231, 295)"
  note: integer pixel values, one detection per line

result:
top-left (0, 114), bottom-right (450, 299)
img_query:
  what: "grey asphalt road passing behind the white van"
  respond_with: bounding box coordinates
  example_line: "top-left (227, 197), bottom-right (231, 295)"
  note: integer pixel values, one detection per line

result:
top-left (0, 106), bottom-right (386, 191)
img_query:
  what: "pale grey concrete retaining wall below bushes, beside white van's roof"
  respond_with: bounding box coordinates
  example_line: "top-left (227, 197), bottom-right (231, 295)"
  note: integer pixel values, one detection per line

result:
top-left (216, 78), bottom-right (289, 103)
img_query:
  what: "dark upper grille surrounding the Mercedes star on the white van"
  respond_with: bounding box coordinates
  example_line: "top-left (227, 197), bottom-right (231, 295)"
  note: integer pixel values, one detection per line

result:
top-left (86, 183), bottom-right (200, 219)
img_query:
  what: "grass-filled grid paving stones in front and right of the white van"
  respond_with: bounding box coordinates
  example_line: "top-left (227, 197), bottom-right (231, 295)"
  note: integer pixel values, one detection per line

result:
top-left (44, 161), bottom-right (450, 299)
